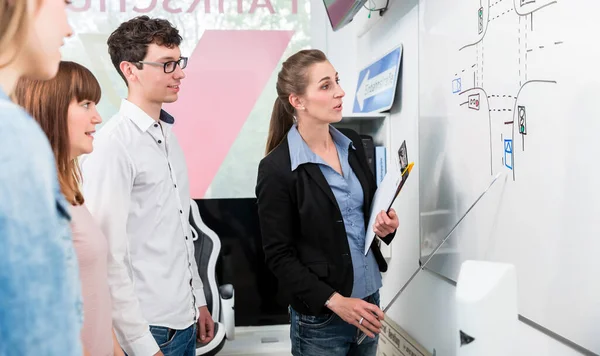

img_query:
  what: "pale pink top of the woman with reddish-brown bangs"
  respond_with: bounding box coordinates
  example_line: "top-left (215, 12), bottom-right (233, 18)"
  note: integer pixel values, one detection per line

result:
top-left (71, 205), bottom-right (114, 356)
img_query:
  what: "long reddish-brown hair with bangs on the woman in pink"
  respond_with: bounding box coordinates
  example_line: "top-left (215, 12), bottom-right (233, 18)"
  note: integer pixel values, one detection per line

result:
top-left (14, 61), bottom-right (101, 205)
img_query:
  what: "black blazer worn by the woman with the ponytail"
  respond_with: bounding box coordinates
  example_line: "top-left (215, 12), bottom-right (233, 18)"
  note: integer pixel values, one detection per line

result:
top-left (256, 129), bottom-right (395, 315)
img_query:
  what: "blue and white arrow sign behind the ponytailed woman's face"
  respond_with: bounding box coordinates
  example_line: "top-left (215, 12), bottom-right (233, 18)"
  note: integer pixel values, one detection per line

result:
top-left (352, 45), bottom-right (402, 113)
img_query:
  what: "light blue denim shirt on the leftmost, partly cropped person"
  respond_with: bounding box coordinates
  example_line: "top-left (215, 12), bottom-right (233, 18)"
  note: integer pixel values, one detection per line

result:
top-left (0, 89), bottom-right (83, 356)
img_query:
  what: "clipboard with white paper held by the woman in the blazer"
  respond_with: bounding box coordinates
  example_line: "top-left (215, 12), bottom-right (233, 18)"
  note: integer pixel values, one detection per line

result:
top-left (364, 141), bottom-right (415, 255)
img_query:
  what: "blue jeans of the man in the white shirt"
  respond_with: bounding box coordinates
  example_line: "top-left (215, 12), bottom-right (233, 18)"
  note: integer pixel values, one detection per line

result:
top-left (150, 323), bottom-right (196, 356)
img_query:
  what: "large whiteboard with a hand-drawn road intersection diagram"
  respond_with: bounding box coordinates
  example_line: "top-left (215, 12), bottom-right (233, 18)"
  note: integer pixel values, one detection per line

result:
top-left (418, 0), bottom-right (600, 354)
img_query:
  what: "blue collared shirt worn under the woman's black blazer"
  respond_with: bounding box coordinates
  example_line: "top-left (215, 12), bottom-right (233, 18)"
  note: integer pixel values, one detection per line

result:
top-left (287, 125), bottom-right (382, 298)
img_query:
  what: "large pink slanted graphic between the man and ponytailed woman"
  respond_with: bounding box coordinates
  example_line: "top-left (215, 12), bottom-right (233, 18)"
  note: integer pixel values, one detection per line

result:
top-left (164, 30), bottom-right (294, 198)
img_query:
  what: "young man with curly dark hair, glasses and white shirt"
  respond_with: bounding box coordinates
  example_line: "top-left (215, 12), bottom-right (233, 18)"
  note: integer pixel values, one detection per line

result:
top-left (81, 16), bottom-right (214, 356)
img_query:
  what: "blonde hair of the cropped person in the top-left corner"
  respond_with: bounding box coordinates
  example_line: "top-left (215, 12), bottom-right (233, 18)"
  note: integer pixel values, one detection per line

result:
top-left (0, 0), bottom-right (31, 68)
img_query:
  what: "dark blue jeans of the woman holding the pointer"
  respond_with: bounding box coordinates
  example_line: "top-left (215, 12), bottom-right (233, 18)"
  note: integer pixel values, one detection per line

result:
top-left (290, 291), bottom-right (379, 356)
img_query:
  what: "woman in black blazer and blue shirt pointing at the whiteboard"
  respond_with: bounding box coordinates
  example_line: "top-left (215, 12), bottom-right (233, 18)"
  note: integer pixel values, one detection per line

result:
top-left (256, 50), bottom-right (398, 356)
